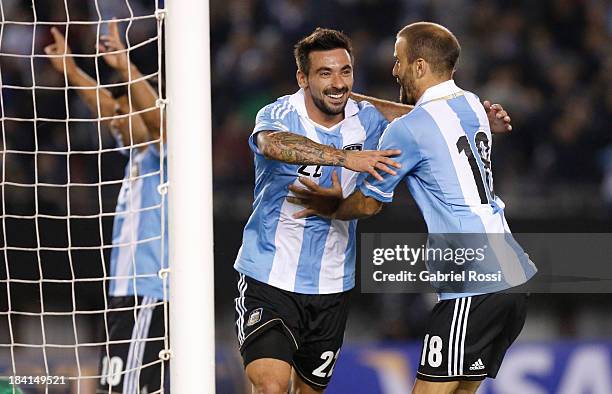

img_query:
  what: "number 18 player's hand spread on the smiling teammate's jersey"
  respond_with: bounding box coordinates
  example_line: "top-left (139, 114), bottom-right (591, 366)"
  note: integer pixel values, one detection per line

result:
top-left (287, 170), bottom-right (342, 219)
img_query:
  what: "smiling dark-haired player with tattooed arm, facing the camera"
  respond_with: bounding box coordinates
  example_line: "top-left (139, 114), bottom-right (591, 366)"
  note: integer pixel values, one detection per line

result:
top-left (234, 29), bottom-right (509, 393)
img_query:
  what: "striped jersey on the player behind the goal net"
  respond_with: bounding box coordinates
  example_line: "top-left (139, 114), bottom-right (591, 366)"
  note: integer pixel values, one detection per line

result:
top-left (109, 145), bottom-right (168, 300)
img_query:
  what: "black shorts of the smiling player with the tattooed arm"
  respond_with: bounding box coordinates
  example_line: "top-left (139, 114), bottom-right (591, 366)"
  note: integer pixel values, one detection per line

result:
top-left (235, 274), bottom-right (350, 390)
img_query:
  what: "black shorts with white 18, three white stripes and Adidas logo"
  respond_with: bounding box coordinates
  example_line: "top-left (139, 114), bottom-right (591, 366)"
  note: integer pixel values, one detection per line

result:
top-left (417, 293), bottom-right (527, 382)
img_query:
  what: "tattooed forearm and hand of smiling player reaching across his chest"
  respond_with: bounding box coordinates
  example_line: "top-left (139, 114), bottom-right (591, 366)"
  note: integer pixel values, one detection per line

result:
top-left (257, 131), bottom-right (401, 180)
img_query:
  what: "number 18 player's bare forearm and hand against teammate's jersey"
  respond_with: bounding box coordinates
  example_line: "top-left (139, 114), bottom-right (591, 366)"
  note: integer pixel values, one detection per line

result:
top-left (287, 171), bottom-right (382, 220)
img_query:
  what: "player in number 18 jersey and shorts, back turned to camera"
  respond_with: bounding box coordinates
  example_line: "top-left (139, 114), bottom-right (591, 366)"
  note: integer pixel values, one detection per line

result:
top-left (288, 22), bottom-right (536, 394)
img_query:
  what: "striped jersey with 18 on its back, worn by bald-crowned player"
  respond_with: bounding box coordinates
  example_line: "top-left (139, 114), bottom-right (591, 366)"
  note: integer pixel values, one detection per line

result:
top-left (359, 80), bottom-right (536, 299)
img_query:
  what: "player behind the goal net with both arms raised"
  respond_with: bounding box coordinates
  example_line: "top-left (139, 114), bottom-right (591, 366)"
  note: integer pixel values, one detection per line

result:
top-left (45, 22), bottom-right (169, 394)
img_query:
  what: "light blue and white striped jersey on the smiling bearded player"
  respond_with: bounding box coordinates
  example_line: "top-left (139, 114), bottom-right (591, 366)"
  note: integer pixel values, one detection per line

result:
top-left (234, 90), bottom-right (388, 294)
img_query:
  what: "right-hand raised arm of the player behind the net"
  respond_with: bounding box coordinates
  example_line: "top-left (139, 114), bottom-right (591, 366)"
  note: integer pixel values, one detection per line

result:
top-left (100, 21), bottom-right (161, 139)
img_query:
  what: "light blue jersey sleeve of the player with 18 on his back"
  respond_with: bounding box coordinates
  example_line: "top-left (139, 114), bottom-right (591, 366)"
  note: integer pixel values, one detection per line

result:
top-left (359, 119), bottom-right (422, 202)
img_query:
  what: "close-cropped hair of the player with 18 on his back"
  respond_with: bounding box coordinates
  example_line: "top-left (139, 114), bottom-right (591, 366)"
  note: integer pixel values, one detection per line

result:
top-left (397, 22), bottom-right (461, 74)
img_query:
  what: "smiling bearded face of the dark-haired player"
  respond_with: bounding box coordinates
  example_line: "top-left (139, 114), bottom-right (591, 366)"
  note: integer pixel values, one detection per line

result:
top-left (298, 48), bottom-right (353, 116)
